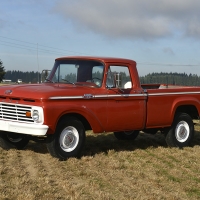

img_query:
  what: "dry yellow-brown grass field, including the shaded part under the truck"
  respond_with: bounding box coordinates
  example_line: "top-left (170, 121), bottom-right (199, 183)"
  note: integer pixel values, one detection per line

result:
top-left (0, 126), bottom-right (200, 200)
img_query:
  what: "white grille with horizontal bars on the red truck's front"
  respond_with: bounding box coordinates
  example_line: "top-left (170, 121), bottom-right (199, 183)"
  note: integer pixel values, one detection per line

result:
top-left (0, 103), bottom-right (34, 123)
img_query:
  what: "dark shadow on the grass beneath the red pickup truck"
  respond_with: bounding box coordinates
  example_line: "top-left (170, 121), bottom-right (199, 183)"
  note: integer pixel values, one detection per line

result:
top-left (26, 131), bottom-right (200, 156)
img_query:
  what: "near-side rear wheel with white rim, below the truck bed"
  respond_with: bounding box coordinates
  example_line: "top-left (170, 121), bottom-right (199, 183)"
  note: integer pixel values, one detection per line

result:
top-left (165, 113), bottom-right (194, 148)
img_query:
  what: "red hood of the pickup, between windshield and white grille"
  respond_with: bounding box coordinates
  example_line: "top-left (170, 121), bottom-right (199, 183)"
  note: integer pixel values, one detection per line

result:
top-left (0, 83), bottom-right (94, 100)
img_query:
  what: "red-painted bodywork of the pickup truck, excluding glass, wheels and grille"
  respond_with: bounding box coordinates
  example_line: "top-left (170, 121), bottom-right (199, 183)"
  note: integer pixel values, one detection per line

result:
top-left (0, 57), bottom-right (200, 134)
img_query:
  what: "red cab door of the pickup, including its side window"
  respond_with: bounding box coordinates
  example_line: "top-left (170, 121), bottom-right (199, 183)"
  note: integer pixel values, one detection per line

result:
top-left (106, 65), bottom-right (146, 131)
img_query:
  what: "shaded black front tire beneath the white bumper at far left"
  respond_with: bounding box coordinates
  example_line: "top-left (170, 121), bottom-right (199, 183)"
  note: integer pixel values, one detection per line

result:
top-left (0, 132), bottom-right (29, 150)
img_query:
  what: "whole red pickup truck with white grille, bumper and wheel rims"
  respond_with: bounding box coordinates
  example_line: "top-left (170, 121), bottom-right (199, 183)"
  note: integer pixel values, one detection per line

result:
top-left (0, 57), bottom-right (200, 159)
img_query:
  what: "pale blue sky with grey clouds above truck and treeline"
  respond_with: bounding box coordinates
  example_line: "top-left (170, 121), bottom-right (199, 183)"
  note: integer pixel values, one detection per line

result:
top-left (0, 0), bottom-right (200, 76)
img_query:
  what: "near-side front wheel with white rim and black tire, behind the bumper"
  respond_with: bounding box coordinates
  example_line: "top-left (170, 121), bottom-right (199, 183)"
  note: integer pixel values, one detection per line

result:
top-left (46, 117), bottom-right (85, 160)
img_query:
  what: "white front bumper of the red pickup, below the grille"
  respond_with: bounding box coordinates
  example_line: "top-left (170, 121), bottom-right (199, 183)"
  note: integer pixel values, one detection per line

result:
top-left (0, 120), bottom-right (49, 136)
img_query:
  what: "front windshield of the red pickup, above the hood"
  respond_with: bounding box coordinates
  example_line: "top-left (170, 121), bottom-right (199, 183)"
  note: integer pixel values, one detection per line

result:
top-left (46, 60), bottom-right (104, 87)
